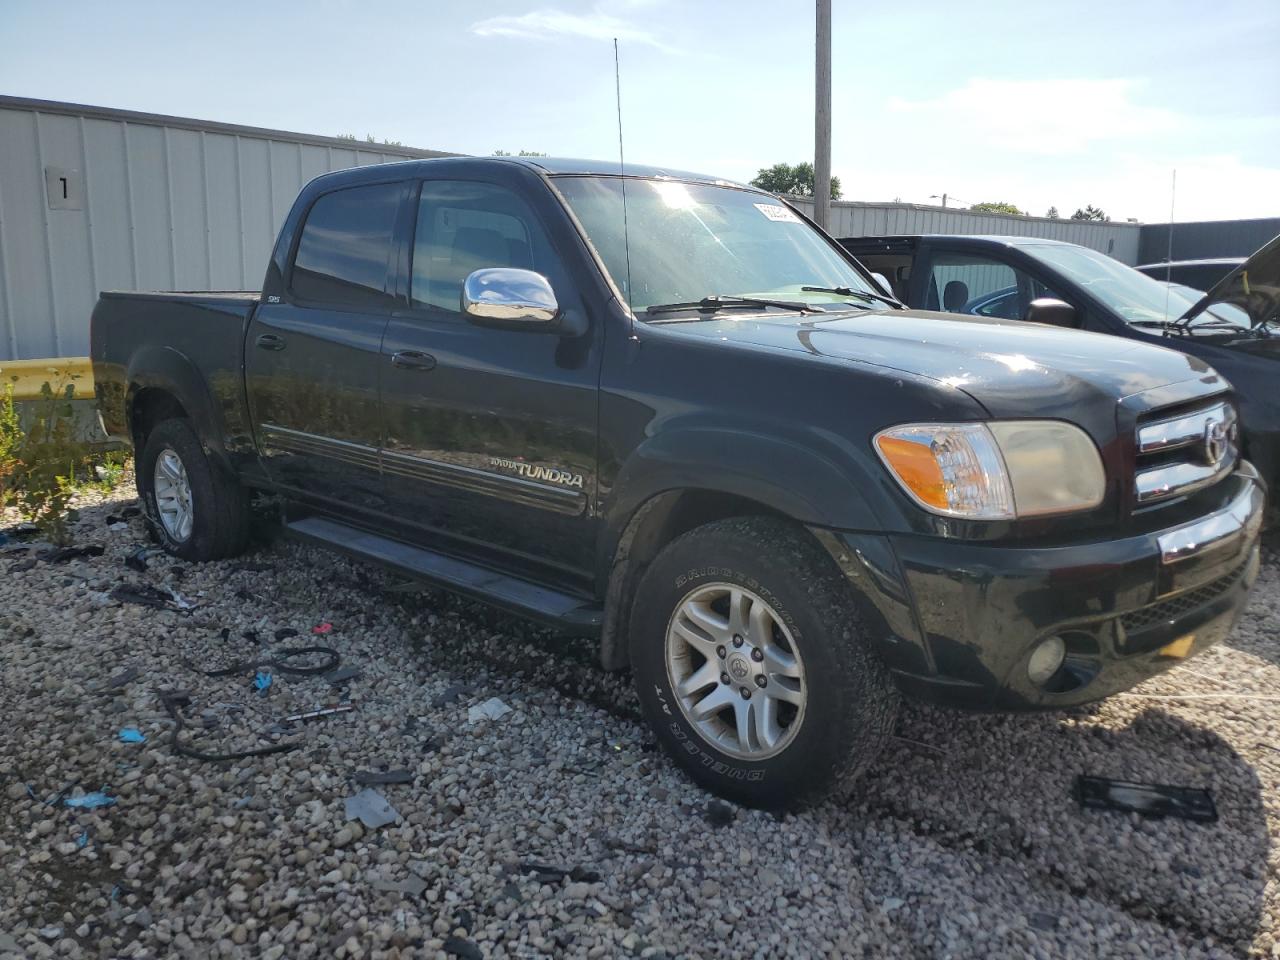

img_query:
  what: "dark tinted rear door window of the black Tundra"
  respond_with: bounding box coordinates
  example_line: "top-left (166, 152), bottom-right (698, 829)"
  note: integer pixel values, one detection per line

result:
top-left (289, 183), bottom-right (402, 307)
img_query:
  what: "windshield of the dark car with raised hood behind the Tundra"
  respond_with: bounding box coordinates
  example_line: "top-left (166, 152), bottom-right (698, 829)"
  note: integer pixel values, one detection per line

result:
top-left (1023, 243), bottom-right (1248, 329)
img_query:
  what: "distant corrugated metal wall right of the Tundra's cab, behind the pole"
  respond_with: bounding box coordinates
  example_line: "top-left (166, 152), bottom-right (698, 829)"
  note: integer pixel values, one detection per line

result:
top-left (791, 198), bottom-right (1140, 266)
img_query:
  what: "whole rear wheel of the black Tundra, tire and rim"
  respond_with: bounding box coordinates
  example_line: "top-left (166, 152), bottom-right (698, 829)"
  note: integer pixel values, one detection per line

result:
top-left (137, 419), bottom-right (248, 561)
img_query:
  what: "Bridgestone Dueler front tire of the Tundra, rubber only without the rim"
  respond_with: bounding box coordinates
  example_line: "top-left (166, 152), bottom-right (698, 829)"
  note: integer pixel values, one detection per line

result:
top-left (630, 517), bottom-right (899, 809)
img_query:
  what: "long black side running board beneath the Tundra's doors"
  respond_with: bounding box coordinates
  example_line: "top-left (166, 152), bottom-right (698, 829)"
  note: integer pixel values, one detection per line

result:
top-left (284, 517), bottom-right (604, 634)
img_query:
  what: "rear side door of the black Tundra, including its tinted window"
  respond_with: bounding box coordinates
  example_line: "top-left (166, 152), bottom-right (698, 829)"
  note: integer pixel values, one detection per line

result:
top-left (244, 180), bottom-right (408, 512)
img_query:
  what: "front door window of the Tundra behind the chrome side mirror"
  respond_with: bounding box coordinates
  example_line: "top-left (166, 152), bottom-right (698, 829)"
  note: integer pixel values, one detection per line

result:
top-left (410, 180), bottom-right (556, 312)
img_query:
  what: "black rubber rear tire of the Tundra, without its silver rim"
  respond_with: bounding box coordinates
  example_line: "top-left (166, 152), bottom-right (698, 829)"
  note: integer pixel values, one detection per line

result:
top-left (136, 419), bottom-right (250, 561)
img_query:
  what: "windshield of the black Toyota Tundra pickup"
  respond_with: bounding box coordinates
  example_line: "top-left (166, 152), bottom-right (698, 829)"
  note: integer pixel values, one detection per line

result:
top-left (556, 177), bottom-right (887, 314)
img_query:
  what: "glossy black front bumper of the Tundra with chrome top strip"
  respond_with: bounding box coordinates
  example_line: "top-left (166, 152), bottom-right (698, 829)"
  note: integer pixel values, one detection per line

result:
top-left (822, 463), bottom-right (1265, 709)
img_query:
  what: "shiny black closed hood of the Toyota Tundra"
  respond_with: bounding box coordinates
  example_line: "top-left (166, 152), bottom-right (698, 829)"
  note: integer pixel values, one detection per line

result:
top-left (675, 310), bottom-right (1226, 420)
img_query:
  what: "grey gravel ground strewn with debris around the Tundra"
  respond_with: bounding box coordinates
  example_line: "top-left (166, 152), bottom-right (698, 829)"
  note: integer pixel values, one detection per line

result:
top-left (0, 488), bottom-right (1280, 957)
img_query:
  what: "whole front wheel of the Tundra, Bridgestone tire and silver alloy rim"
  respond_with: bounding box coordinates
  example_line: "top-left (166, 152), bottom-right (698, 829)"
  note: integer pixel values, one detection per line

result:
top-left (630, 517), bottom-right (897, 809)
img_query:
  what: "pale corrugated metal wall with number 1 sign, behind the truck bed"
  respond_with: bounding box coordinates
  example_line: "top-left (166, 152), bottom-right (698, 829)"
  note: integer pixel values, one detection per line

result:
top-left (0, 97), bottom-right (455, 360)
